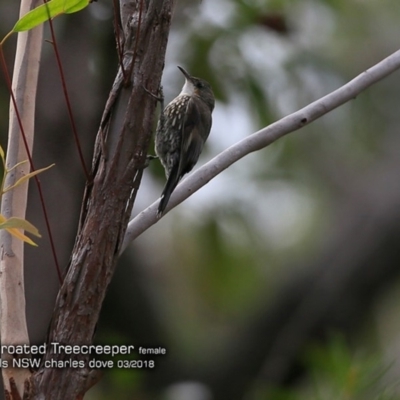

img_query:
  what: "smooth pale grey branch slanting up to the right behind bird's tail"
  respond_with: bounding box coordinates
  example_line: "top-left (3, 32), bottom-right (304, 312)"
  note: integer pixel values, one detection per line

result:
top-left (121, 50), bottom-right (400, 252)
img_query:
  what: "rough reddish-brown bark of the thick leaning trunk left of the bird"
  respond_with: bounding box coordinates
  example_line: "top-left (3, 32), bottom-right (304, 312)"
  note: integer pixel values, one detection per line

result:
top-left (28, 0), bottom-right (173, 400)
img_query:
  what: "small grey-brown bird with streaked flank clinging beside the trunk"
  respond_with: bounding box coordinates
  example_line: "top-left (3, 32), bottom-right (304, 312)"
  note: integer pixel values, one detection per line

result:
top-left (155, 66), bottom-right (215, 218)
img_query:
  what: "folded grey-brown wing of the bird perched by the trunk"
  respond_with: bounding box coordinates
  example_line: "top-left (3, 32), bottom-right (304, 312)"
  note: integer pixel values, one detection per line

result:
top-left (178, 97), bottom-right (211, 179)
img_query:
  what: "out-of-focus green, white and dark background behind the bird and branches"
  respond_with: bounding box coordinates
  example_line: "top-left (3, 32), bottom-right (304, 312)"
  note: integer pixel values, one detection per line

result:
top-left (0, 0), bottom-right (400, 400)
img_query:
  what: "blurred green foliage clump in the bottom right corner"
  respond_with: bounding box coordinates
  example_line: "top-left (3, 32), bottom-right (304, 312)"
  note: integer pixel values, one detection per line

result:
top-left (260, 335), bottom-right (400, 400)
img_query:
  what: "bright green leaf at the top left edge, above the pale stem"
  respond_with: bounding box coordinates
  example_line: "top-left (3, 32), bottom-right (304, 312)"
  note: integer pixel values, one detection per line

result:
top-left (13, 0), bottom-right (89, 32)
